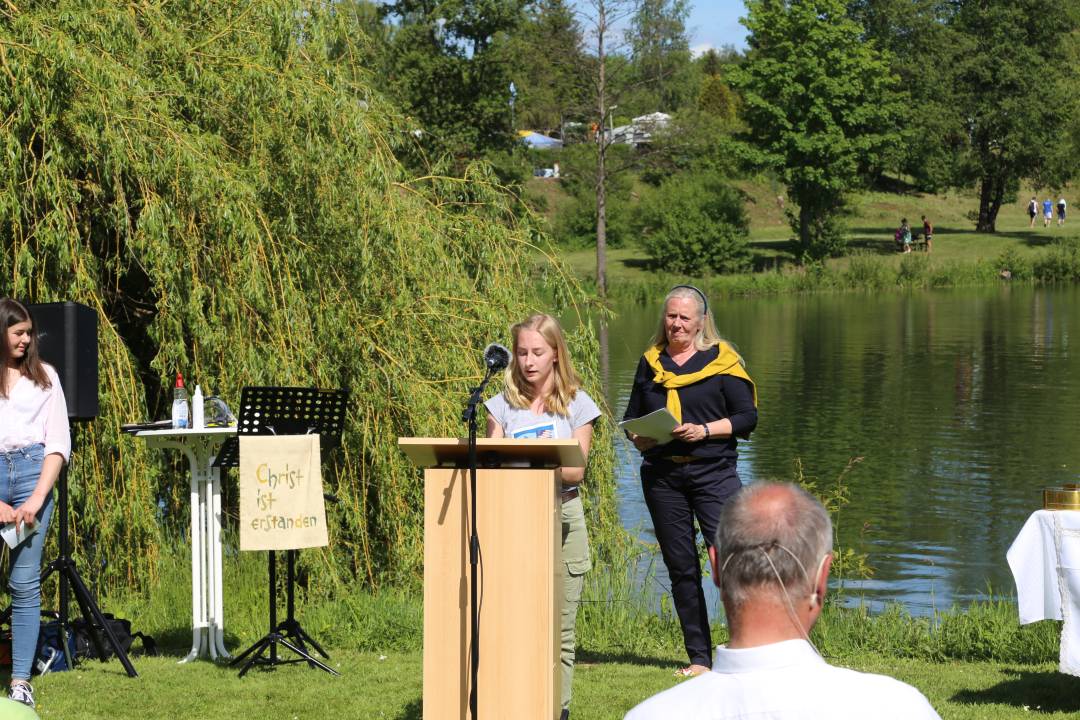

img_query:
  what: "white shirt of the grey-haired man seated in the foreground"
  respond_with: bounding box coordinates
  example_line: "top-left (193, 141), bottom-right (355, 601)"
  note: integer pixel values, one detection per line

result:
top-left (624, 640), bottom-right (941, 720)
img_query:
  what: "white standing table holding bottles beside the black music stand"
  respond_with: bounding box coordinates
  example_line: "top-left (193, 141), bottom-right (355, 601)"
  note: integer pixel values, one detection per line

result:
top-left (136, 427), bottom-right (237, 663)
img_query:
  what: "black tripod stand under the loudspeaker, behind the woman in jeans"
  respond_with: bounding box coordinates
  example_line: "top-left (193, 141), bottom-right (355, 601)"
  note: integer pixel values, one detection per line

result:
top-left (41, 422), bottom-right (138, 678)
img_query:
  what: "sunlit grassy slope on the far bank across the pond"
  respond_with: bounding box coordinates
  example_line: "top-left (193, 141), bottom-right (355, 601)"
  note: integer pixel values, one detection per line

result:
top-left (563, 180), bottom-right (1080, 297)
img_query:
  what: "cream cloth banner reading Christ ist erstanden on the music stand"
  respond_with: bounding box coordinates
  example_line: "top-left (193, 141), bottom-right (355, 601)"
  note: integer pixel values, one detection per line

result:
top-left (240, 434), bottom-right (329, 551)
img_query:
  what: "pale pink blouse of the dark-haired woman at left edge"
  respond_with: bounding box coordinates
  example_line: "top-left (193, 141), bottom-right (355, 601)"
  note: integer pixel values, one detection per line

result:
top-left (0, 364), bottom-right (71, 462)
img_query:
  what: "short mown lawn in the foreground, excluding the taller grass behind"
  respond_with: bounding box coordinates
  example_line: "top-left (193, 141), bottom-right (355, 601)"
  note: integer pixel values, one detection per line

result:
top-left (29, 648), bottom-right (1080, 720)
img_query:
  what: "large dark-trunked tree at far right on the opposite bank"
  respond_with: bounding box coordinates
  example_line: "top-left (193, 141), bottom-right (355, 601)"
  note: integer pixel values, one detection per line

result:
top-left (950, 0), bottom-right (1080, 232)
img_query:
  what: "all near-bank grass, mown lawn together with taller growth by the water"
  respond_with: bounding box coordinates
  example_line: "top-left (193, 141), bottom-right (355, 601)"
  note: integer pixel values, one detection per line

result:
top-left (21, 543), bottom-right (1080, 720)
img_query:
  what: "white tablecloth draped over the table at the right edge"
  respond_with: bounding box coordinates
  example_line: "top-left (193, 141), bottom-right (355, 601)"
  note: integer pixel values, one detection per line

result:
top-left (1007, 510), bottom-right (1080, 676)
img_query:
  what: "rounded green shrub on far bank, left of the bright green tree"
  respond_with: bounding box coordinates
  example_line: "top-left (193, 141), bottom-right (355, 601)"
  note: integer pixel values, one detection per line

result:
top-left (638, 174), bottom-right (751, 275)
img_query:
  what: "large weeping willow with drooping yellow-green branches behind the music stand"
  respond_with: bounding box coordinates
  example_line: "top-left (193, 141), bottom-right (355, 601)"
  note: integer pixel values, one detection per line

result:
top-left (0, 0), bottom-right (611, 585)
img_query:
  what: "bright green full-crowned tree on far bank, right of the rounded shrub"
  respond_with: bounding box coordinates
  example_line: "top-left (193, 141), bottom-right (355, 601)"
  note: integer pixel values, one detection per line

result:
top-left (729, 0), bottom-right (903, 257)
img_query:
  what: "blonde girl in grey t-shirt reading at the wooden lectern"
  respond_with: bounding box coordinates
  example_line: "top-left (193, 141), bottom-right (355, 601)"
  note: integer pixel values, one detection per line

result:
top-left (485, 315), bottom-right (600, 720)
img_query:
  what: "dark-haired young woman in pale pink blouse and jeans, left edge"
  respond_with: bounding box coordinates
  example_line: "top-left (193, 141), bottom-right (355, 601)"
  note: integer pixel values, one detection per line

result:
top-left (0, 298), bottom-right (71, 707)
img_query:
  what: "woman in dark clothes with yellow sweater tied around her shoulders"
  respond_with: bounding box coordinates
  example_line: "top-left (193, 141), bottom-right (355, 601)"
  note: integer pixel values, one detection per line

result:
top-left (624, 285), bottom-right (757, 676)
